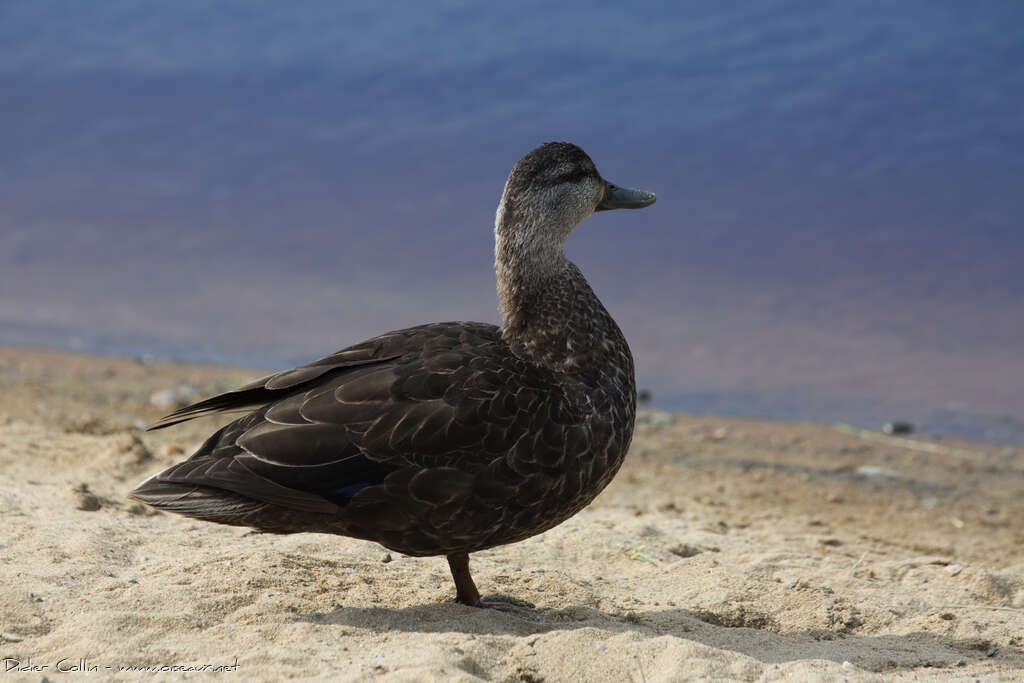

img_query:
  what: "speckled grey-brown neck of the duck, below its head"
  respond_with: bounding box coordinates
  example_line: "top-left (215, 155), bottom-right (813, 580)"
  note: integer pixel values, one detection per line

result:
top-left (495, 216), bottom-right (632, 373)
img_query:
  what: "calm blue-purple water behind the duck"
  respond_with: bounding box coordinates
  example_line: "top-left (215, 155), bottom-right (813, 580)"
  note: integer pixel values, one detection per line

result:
top-left (0, 1), bottom-right (1024, 442)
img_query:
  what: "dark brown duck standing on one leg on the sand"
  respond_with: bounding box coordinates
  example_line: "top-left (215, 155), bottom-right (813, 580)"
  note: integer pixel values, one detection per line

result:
top-left (129, 142), bottom-right (655, 609)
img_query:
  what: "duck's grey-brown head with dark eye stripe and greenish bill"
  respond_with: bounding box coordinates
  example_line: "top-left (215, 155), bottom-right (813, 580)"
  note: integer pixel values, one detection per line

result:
top-left (495, 142), bottom-right (655, 260)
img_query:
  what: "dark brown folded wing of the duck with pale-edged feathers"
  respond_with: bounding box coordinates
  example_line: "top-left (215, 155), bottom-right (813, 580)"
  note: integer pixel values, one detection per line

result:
top-left (133, 323), bottom-right (578, 514)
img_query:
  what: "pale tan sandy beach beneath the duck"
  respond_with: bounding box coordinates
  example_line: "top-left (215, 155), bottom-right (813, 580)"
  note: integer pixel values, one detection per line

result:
top-left (0, 348), bottom-right (1024, 682)
